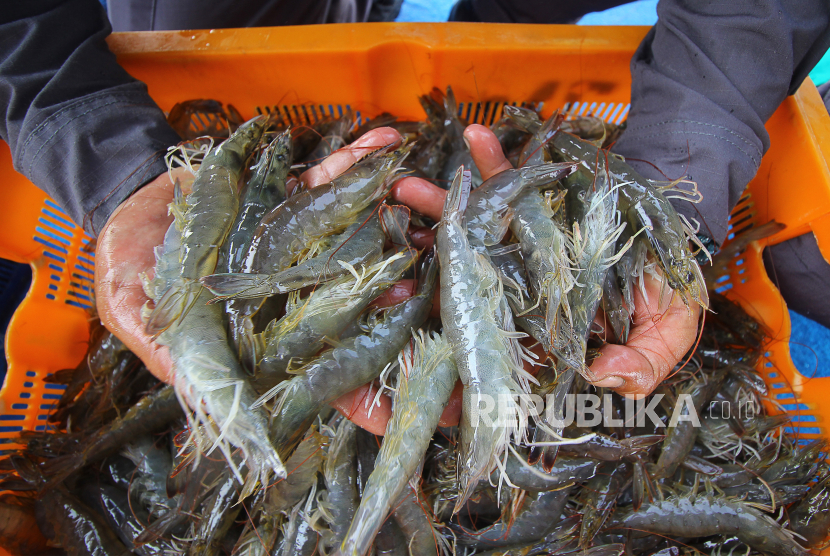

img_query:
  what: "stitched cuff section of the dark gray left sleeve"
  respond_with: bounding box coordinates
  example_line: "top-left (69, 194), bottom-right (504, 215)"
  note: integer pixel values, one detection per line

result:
top-left (14, 82), bottom-right (180, 236)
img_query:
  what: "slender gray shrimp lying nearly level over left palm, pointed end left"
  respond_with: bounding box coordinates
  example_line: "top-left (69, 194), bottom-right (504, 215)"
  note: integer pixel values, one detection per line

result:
top-left (202, 205), bottom-right (394, 299)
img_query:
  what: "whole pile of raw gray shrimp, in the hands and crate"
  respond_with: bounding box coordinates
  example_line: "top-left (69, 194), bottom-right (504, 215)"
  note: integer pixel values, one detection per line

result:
top-left (0, 89), bottom-right (830, 556)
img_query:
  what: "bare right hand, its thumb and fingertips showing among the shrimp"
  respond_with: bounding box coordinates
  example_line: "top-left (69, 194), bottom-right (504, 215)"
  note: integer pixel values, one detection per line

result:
top-left (392, 125), bottom-right (700, 397)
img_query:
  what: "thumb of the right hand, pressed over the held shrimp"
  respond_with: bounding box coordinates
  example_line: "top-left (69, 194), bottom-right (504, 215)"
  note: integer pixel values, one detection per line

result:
top-left (591, 276), bottom-right (700, 398)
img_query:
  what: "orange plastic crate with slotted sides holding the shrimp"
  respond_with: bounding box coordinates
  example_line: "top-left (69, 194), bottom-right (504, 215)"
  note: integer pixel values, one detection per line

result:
top-left (0, 23), bottom-right (830, 548)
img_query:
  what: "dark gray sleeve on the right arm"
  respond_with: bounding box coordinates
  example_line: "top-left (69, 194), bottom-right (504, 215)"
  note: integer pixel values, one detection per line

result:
top-left (614, 0), bottom-right (830, 248)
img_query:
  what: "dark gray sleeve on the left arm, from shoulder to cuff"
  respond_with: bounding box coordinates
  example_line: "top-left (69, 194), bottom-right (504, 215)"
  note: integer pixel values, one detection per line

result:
top-left (0, 0), bottom-right (179, 235)
